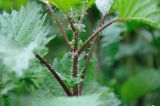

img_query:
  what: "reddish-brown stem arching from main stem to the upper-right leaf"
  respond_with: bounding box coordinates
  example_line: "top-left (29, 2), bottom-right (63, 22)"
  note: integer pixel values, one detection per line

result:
top-left (78, 19), bottom-right (121, 54)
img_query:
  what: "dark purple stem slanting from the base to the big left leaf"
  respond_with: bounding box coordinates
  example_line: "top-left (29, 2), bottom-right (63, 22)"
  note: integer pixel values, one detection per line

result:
top-left (35, 54), bottom-right (73, 96)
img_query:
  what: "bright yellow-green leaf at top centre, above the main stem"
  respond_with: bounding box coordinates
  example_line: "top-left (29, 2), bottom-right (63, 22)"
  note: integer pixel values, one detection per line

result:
top-left (48, 0), bottom-right (94, 12)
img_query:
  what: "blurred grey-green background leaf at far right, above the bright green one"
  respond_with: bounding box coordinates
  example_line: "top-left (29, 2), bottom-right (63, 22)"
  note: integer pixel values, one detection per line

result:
top-left (116, 29), bottom-right (155, 60)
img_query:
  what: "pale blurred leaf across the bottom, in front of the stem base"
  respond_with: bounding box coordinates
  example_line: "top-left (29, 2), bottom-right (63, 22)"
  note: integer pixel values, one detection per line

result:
top-left (30, 89), bottom-right (120, 106)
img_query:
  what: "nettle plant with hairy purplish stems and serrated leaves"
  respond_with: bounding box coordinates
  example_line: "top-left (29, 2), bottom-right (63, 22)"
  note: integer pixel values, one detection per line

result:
top-left (0, 0), bottom-right (160, 106)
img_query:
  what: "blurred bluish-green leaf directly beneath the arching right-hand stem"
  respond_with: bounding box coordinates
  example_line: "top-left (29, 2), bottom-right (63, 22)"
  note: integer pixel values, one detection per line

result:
top-left (100, 24), bottom-right (126, 67)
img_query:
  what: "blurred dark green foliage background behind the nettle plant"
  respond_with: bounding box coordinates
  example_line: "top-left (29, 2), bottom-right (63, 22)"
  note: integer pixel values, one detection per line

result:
top-left (0, 0), bottom-right (160, 106)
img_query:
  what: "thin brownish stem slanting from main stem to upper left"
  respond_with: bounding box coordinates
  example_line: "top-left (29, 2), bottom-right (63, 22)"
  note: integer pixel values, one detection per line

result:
top-left (45, 2), bottom-right (73, 52)
